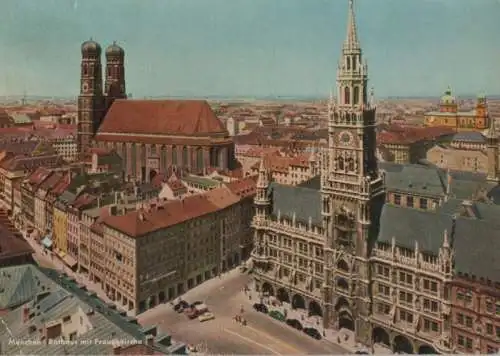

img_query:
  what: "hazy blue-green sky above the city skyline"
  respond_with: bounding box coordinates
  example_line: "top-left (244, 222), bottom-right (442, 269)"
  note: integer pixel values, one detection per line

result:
top-left (0, 0), bottom-right (500, 97)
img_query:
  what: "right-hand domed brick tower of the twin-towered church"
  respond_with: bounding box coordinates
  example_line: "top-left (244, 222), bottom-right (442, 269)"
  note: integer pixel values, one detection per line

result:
top-left (105, 42), bottom-right (127, 110)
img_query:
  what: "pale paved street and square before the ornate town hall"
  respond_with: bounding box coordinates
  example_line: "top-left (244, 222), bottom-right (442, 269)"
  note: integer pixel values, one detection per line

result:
top-left (138, 269), bottom-right (348, 355)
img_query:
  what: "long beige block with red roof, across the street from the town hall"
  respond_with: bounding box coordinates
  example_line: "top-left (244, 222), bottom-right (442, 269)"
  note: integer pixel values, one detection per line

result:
top-left (103, 187), bottom-right (251, 312)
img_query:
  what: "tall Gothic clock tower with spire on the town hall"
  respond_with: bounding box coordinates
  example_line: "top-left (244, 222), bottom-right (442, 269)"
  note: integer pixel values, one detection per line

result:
top-left (321, 0), bottom-right (385, 343)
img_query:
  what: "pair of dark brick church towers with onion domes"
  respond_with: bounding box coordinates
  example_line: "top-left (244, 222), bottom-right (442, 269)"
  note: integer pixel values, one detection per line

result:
top-left (77, 39), bottom-right (127, 154)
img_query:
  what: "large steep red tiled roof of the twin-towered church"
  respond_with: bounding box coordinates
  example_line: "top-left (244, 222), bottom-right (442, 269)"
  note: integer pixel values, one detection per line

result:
top-left (97, 100), bottom-right (227, 136)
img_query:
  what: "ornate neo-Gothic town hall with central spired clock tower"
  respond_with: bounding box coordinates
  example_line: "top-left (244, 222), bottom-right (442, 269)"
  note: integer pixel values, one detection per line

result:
top-left (252, 0), bottom-right (500, 353)
